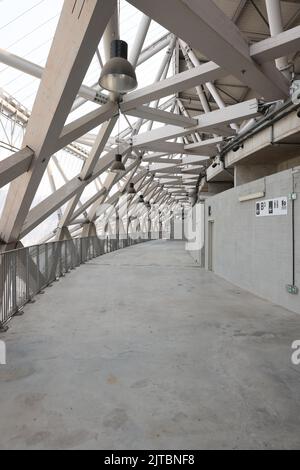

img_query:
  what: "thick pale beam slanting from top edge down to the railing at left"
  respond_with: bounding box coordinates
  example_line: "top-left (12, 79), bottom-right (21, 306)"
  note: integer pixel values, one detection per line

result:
top-left (0, 0), bottom-right (115, 244)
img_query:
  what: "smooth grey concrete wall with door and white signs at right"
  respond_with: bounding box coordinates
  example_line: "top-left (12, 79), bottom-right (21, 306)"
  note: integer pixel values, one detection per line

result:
top-left (205, 167), bottom-right (300, 313)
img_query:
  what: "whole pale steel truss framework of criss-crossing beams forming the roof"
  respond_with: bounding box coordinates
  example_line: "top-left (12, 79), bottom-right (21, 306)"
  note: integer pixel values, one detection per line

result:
top-left (0, 0), bottom-right (300, 247)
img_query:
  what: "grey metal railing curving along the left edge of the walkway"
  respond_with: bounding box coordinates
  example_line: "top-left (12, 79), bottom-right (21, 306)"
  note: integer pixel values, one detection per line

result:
top-left (0, 234), bottom-right (151, 331)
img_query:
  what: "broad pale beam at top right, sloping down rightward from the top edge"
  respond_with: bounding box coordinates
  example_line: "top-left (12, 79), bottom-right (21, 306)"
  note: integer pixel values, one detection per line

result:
top-left (129, 0), bottom-right (289, 100)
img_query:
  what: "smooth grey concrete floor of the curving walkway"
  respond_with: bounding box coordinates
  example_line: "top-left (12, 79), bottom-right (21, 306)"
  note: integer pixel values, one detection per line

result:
top-left (0, 241), bottom-right (300, 450)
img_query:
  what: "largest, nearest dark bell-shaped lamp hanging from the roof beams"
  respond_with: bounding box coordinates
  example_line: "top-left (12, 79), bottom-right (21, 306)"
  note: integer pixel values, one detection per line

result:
top-left (99, 39), bottom-right (138, 93)
